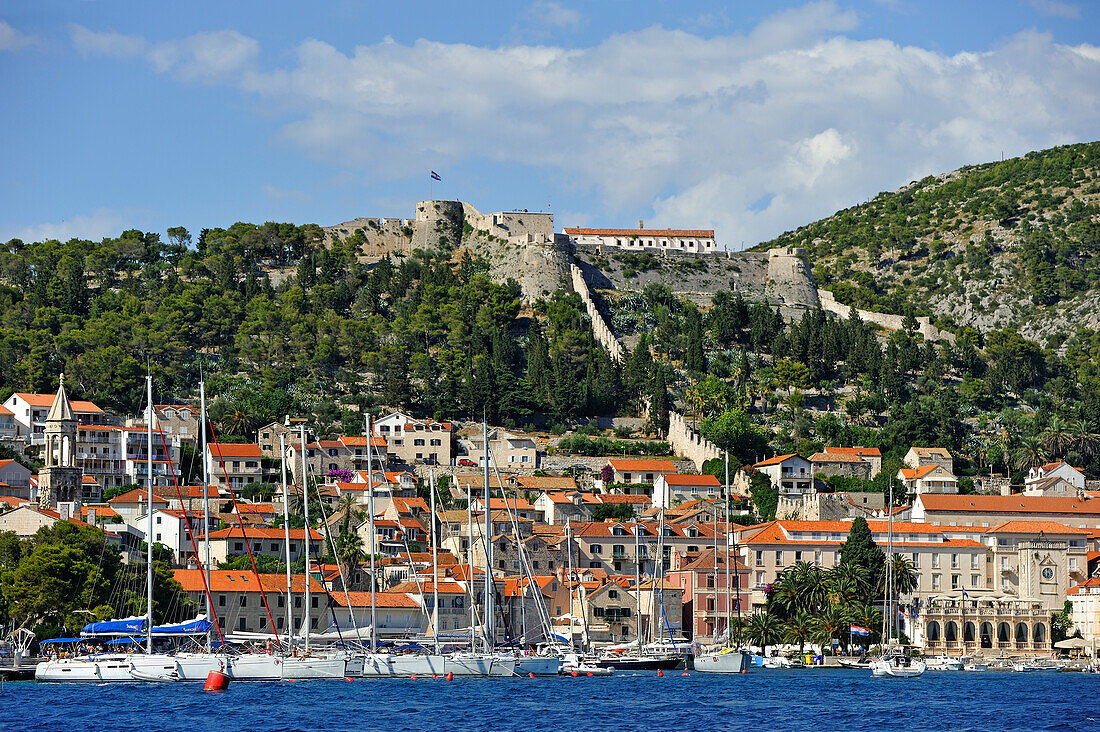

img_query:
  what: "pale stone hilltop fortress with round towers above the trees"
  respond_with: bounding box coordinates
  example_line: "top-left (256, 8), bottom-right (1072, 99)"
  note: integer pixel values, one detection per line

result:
top-left (325, 200), bottom-right (950, 340)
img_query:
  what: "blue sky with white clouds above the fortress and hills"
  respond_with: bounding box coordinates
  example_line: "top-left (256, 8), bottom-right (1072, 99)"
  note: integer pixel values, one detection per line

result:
top-left (0, 0), bottom-right (1100, 250)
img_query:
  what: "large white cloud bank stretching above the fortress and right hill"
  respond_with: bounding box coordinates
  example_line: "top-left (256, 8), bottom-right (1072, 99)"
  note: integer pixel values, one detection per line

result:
top-left (74, 2), bottom-right (1100, 247)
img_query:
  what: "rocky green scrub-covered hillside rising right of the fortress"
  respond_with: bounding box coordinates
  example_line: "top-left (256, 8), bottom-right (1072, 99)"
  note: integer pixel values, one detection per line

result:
top-left (756, 142), bottom-right (1100, 347)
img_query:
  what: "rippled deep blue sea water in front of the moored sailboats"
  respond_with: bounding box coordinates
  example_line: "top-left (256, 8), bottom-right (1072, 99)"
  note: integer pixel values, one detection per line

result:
top-left (0, 669), bottom-right (1100, 732)
